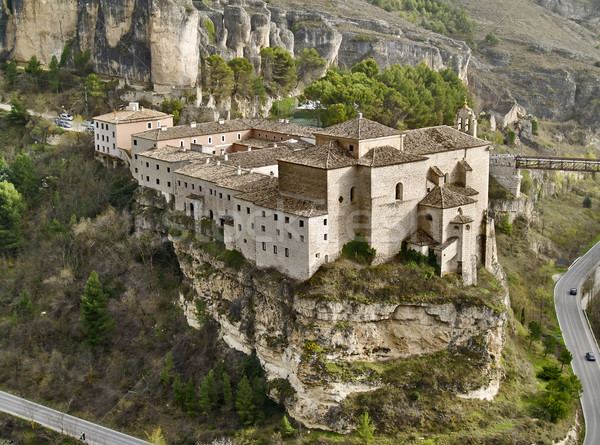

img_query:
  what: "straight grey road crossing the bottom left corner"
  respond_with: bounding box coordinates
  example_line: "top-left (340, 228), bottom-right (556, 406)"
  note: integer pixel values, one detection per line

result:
top-left (0, 391), bottom-right (148, 445)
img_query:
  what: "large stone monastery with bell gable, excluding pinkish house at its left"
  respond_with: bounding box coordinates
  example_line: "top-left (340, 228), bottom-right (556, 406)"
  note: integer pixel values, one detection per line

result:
top-left (124, 105), bottom-right (489, 284)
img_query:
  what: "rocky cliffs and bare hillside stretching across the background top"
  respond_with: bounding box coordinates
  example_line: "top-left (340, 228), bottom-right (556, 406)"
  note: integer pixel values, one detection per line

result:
top-left (0, 0), bottom-right (600, 129)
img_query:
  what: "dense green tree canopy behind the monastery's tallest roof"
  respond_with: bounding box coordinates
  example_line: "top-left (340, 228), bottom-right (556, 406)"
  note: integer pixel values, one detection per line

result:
top-left (304, 59), bottom-right (470, 129)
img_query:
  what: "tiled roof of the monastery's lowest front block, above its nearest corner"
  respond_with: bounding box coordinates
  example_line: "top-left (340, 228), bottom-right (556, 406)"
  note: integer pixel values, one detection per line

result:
top-left (237, 186), bottom-right (327, 218)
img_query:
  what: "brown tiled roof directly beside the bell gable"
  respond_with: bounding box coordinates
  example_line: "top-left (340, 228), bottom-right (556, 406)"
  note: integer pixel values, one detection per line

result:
top-left (404, 125), bottom-right (489, 155)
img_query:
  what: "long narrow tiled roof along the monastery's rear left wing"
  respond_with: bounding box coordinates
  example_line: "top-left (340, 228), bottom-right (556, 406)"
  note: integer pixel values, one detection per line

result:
top-left (135, 119), bottom-right (314, 141)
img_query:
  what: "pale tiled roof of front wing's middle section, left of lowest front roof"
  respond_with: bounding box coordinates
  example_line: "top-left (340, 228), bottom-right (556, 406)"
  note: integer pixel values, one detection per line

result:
top-left (175, 161), bottom-right (276, 192)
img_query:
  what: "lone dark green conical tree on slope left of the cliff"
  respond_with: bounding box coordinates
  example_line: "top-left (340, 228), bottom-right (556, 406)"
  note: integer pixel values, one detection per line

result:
top-left (81, 271), bottom-right (115, 346)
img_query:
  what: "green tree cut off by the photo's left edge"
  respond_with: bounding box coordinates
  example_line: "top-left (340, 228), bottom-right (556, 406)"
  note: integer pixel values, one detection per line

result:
top-left (0, 181), bottom-right (25, 252)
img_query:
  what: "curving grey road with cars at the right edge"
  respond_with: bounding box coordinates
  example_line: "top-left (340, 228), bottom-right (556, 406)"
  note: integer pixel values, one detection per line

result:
top-left (554, 243), bottom-right (600, 445)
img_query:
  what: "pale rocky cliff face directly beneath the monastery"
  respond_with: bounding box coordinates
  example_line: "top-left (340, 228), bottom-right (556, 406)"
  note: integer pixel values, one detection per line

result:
top-left (165, 225), bottom-right (508, 432)
